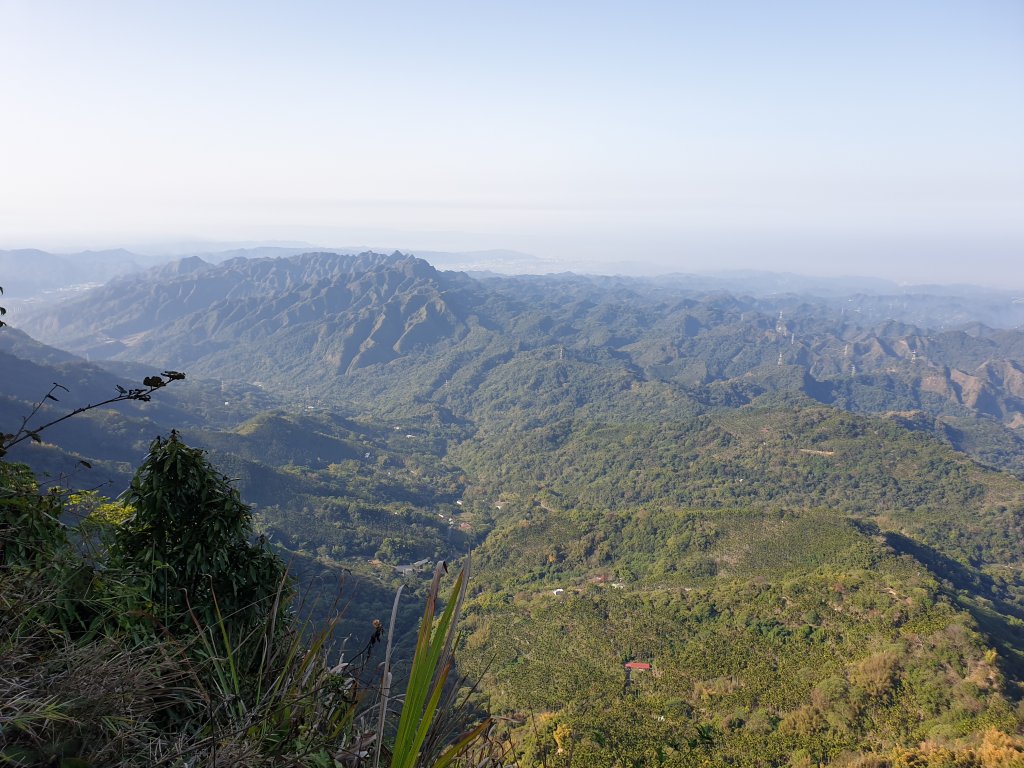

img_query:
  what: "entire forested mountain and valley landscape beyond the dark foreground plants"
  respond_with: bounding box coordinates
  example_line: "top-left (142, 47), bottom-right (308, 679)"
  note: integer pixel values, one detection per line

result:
top-left (0, 254), bottom-right (1024, 766)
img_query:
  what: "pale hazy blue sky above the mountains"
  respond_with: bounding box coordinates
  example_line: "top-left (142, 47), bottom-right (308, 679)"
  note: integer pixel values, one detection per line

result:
top-left (0, 0), bottom-right (1024, 285)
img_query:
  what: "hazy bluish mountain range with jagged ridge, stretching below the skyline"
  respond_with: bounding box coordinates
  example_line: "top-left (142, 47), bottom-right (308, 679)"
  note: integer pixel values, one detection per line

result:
top-left (18, 252), bottom-right (1024, 448)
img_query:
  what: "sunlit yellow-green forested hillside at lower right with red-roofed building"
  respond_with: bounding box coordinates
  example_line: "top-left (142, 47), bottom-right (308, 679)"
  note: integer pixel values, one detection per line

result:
top-left (452, 399), bottom-right (1024, 765)
